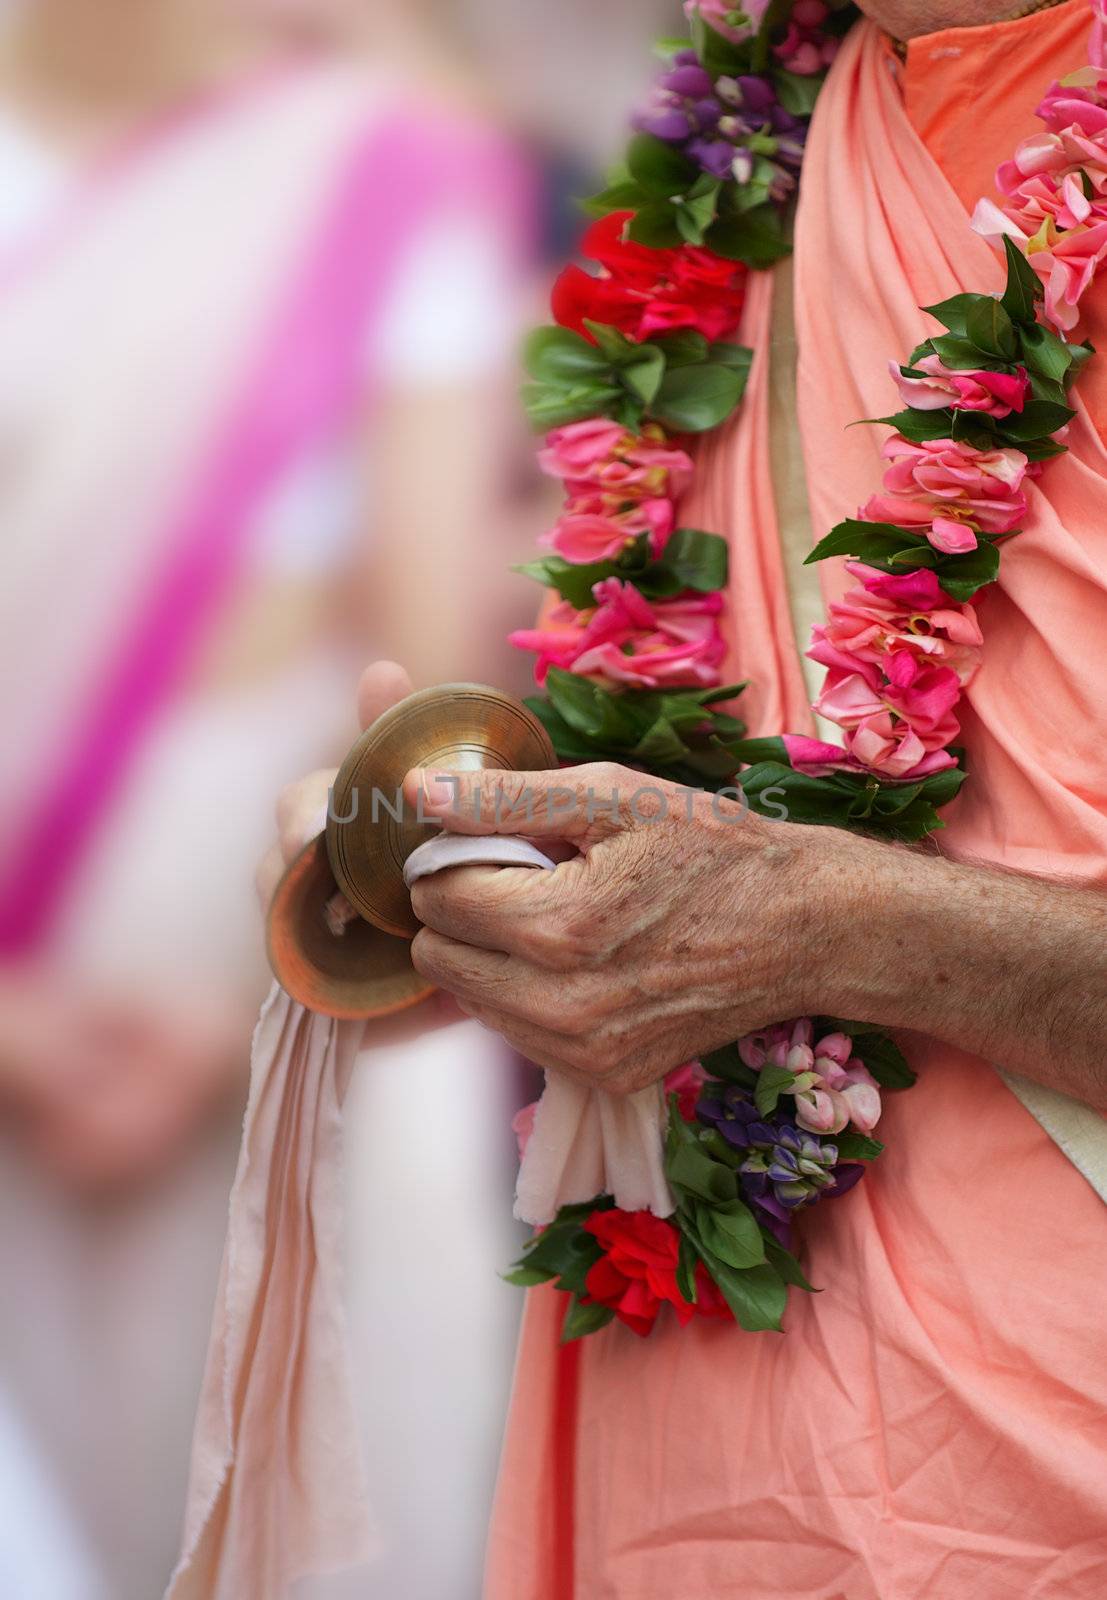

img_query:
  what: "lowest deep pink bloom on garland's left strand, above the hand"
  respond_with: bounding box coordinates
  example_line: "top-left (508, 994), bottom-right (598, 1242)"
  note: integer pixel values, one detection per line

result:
top-left (510, 578), bottom-right (726, 690)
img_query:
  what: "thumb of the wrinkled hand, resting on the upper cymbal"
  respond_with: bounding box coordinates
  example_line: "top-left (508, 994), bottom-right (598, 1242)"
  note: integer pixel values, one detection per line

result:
top-left (403, 762), bottom-right (641, 840)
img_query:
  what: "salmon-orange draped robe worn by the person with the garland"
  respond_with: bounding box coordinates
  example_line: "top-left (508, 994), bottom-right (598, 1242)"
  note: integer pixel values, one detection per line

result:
top-left (486, 0), bottom-right (1107, 1600)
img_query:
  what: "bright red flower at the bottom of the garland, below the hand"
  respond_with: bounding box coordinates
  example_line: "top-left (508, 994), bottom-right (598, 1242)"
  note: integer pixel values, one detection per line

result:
top-left (582, 1210), bottom-right (731, 1339)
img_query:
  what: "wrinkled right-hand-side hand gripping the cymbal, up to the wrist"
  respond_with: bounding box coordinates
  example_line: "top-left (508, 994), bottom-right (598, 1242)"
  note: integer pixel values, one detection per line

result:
top-left (405, 765), bottom-right (859, 1093)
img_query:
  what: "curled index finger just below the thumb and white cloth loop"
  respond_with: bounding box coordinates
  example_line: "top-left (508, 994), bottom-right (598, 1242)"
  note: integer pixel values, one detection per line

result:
top-left (411, 856), bottom-right (585, 965)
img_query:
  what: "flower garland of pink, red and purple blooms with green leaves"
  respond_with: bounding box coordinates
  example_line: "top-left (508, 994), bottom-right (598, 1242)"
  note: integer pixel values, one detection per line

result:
top-left (509, 0), bottom-right (1107, 1339)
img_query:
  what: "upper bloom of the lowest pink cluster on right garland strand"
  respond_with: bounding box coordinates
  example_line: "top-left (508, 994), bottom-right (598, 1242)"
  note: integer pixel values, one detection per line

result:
top-left (808, 562), bottom-right (984, 683)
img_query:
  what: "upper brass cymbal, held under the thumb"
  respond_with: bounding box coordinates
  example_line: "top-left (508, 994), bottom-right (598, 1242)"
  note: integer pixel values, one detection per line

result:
top-left (326, 683), bottom-right (557, 939)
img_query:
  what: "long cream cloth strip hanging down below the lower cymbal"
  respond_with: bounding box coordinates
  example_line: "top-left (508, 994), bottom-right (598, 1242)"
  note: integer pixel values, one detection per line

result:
top-left (166, 986), bottom-right (374, 1600)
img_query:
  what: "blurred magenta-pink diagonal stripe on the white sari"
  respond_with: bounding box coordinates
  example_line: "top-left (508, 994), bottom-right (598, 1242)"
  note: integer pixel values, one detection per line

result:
top-left (0, 110), bottom-right (524, 954)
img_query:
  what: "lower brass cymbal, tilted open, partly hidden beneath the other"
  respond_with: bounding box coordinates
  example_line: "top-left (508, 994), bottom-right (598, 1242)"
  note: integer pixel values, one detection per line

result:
top-left (266, 834), bottom-right (434, 1018)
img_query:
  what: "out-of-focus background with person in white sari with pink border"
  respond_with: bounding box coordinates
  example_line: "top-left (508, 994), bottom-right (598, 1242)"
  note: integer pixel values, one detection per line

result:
top-left (0, 0), bottom-right (680, 1600)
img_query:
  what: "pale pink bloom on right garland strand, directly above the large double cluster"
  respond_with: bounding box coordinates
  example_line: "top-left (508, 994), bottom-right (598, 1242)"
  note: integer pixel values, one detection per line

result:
top-left (861, 434), bottom-right (1027, 549)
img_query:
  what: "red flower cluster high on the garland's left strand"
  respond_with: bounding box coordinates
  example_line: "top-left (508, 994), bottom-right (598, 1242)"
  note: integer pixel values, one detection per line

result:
top-left (550, 211), bottom-right (745, 339)
